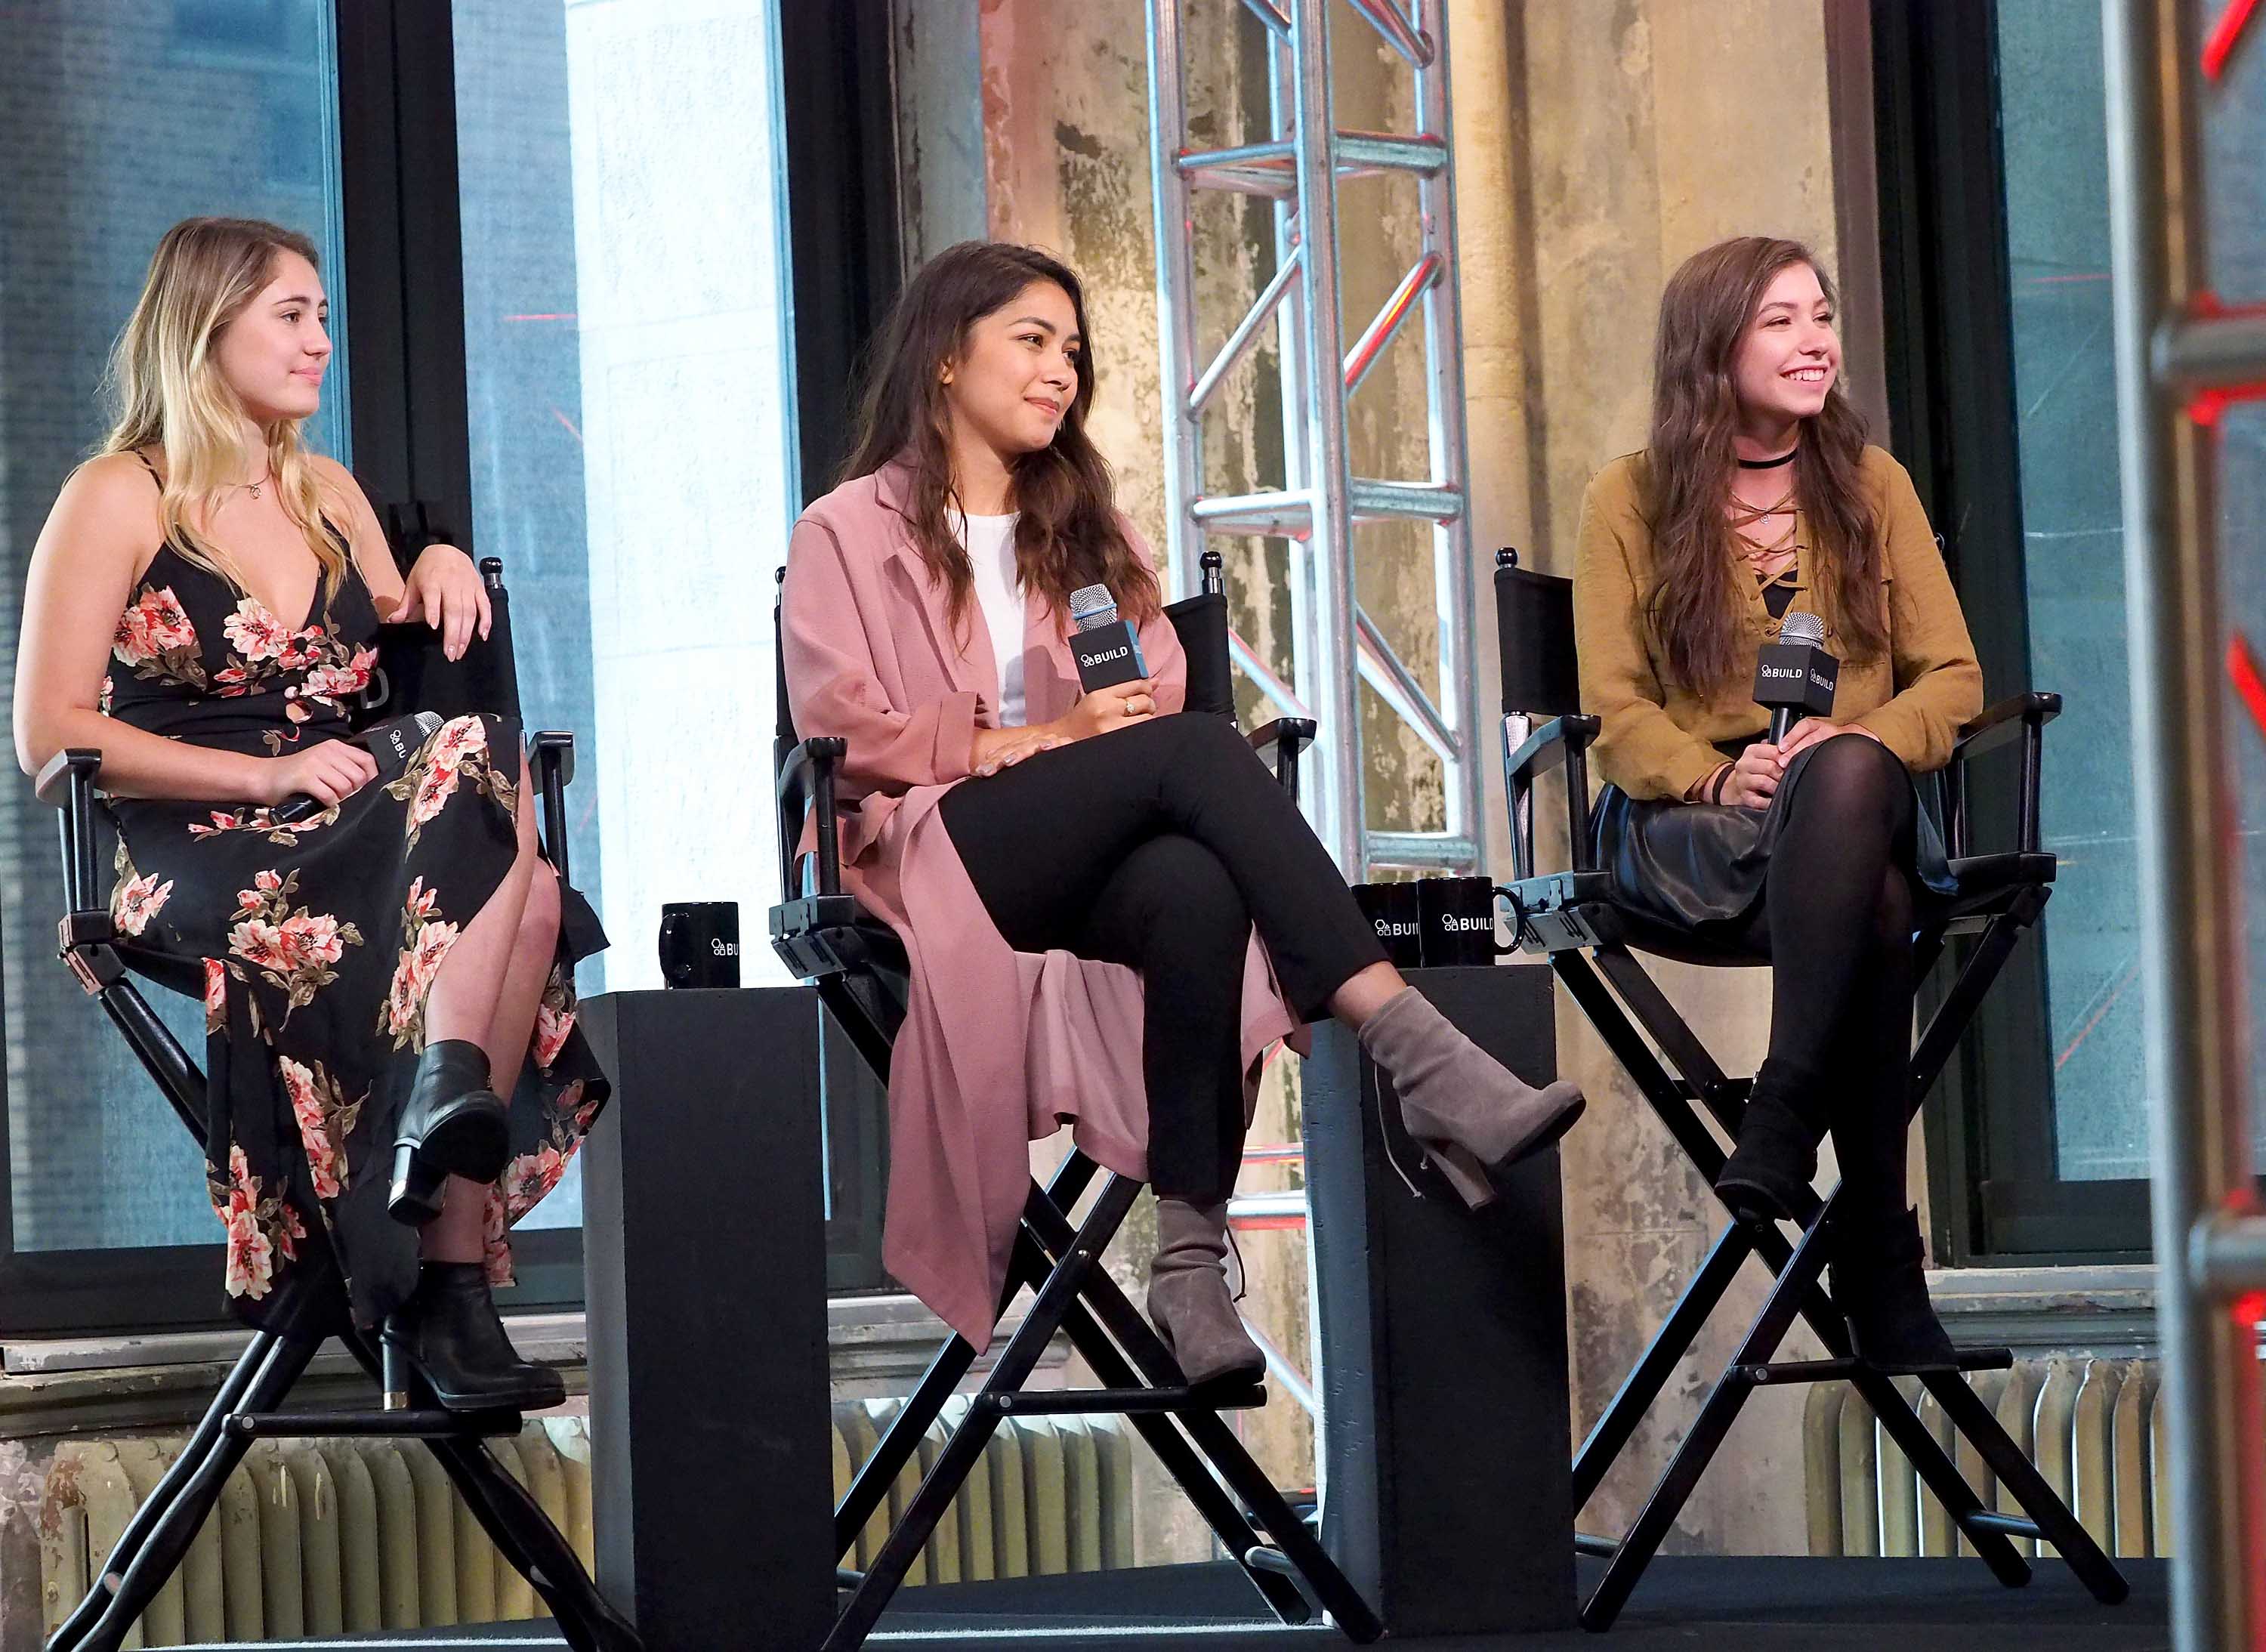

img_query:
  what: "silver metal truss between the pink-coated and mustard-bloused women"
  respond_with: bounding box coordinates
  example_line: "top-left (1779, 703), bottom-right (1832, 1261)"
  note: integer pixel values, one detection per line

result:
top-left (1149, 0), bottom-right (1482, 882)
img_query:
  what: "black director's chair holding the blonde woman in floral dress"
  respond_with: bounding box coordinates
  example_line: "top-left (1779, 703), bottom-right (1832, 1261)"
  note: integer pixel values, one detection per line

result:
top-left (39, 508), bottom-right (641, 1652)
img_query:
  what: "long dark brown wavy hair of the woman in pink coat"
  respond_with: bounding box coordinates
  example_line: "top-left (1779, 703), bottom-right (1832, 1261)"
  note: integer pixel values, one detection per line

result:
top-left (843, 240), bottom-right (1162, 628)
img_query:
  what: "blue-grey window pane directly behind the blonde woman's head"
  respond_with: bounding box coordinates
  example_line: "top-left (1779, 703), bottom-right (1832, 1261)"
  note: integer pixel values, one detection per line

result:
top-left (0, 0), bottom-right (351, 1328)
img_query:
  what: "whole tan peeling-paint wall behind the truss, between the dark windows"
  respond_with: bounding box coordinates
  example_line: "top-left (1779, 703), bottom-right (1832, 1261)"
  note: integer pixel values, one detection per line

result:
top-left (906, 0), bottom-right (1865, 1559)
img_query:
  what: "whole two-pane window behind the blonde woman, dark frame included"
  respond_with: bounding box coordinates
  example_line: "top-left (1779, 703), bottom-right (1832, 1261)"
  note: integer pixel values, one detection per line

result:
top-left (0, 0), bottom-right (825, 1335)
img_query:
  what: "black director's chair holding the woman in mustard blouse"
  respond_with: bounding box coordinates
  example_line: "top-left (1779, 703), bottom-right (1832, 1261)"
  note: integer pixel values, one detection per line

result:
top-left (1496, 551), bottom-right (2126, 1629)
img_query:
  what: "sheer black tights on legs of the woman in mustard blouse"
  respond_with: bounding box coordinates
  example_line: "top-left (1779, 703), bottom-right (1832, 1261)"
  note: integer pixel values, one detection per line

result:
top-left (1743, 734), bottom-right (1919, 1228)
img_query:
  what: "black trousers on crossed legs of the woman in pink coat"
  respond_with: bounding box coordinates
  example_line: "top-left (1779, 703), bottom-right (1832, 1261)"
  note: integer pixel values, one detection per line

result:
top-left (940, 712), bottom-right (1385, 1203)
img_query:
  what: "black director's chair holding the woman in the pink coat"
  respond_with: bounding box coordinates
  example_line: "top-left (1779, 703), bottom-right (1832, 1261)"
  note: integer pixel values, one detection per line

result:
top-left (770, 551), bottom-right (1382, 1652)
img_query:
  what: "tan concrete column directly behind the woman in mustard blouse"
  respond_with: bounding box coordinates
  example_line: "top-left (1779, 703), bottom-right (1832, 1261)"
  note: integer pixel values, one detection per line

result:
top-left (1496, 0), bottom-right (1838, 1552)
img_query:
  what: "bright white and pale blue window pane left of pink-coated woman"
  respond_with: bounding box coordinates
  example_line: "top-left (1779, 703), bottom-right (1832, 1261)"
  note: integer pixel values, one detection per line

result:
top-left (455, 0), bottom-right (800, 988)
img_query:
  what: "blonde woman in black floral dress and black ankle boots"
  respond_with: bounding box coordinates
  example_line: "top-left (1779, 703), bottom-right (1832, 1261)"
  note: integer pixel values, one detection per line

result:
top-left (16, 218), bottom-right (607, 1410)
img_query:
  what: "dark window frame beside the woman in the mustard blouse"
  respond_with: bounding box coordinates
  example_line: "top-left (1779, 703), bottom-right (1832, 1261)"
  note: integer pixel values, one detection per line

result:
top-left (1872, 0), bottom-right (2150, 1267)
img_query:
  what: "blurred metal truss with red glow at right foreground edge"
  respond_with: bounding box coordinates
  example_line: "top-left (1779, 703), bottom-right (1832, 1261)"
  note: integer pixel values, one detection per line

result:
top-left (2103, 0), bottom-right (2266, 1652)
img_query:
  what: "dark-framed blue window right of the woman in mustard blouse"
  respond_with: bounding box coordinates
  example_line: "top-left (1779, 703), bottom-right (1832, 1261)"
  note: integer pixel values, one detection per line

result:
top-left (1874, 0), bottom-right (2266, 1258)
